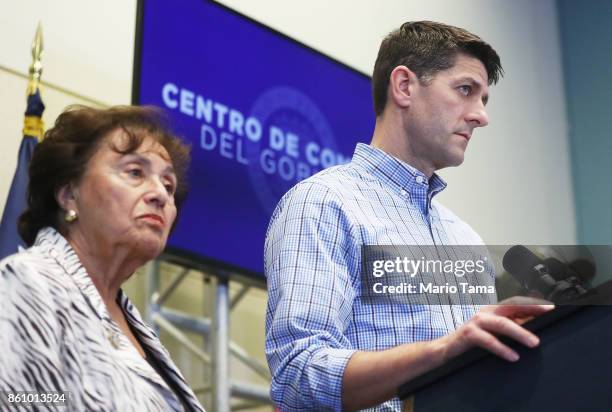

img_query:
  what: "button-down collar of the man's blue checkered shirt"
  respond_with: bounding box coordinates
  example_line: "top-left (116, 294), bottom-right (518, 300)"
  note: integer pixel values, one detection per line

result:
top-left (352, 143), bottom-right (446, 200)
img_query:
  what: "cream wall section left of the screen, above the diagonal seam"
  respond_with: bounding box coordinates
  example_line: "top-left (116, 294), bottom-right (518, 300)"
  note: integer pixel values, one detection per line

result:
top-left (0, 0), bottom-right (136, 104)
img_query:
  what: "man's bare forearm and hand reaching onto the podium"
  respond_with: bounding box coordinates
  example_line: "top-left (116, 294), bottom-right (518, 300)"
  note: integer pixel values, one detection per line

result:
top-left (342, 296), bottom-right (554, 410)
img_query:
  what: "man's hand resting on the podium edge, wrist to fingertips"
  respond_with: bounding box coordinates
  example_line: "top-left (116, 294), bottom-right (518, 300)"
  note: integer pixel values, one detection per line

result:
top-left (441, 296), bottom-right (554, 362)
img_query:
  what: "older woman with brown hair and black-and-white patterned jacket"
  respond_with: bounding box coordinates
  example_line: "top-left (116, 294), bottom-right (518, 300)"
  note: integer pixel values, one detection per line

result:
top-left (0, 107), bottom-right (203, 412)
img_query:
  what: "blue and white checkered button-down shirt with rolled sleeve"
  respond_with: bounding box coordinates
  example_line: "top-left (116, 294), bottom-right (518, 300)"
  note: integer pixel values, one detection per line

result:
top-left (265, 144), bottom-right (494, 411)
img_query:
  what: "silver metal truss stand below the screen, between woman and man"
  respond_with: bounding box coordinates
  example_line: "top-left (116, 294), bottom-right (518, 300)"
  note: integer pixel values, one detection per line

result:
top-left (145, 259), bottom-right (271, 412)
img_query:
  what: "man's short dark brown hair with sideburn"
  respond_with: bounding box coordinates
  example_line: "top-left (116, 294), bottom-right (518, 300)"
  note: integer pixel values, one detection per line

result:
top-left (372, 21), bottom-right (503, 116)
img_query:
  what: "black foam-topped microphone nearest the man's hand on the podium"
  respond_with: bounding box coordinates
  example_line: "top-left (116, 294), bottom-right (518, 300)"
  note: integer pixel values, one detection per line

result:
top-left (502, 245), bottom-right (586, 303)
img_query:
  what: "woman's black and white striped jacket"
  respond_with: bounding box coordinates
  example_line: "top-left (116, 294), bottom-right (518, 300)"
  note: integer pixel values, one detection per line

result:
top-left (0, 228), bottom-right (204, 412)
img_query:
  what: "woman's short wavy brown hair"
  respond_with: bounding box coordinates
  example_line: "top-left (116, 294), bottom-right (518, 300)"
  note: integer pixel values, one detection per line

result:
top-left (18, 106), bottom-right (190, 245)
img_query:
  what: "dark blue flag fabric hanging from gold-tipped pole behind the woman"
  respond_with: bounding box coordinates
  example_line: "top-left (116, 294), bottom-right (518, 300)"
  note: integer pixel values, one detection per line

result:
top-left (0, 89), bottom-right (45, 259)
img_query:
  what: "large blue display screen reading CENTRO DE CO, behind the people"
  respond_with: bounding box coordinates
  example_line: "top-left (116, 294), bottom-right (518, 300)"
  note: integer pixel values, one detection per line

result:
top-left (133, 0), bottom-right (374, 278)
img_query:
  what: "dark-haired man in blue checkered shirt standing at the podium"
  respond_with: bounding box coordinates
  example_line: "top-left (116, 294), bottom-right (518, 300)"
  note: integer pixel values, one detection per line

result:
top-left (265, 22), bottom-right (551, 411)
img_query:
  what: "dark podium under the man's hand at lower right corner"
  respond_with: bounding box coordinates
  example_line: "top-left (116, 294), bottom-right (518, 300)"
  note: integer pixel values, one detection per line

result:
top-left (398, 282), bottom-right (612, 412)
